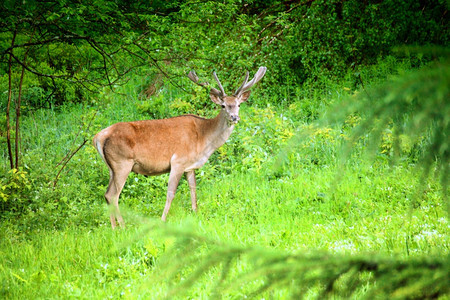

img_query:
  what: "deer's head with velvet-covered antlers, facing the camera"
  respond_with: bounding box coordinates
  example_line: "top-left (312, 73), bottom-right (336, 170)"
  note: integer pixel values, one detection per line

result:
top-left (188, 67), bottom-right (267, 125)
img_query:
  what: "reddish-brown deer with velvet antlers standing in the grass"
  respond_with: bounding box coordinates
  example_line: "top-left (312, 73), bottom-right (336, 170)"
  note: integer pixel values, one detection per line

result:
top-left (93, 67), bottom-right (267, 229)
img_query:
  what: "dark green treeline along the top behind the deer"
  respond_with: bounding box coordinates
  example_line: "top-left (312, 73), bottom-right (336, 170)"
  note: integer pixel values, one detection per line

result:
top-left (0, 0), bottom-right (449, 110)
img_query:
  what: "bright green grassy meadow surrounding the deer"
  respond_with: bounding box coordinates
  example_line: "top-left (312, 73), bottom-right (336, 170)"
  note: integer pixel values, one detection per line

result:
top-left (0, 59), bottom-right (450, 299)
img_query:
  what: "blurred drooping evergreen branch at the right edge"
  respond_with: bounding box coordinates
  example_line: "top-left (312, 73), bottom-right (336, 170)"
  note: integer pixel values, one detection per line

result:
top-left (329, 48), bottom-right (450, 203)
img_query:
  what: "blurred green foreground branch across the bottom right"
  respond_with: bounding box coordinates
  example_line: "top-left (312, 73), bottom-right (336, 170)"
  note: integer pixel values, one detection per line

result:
top-left (146, 226), bottom-right (450, 299)
